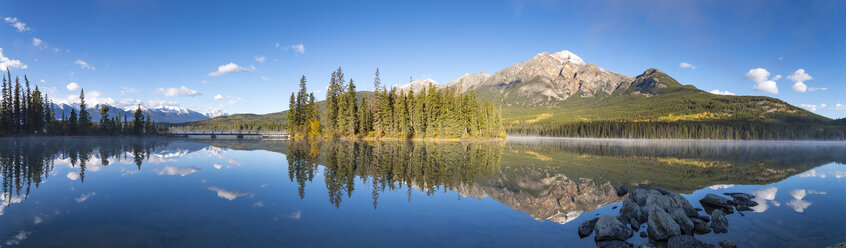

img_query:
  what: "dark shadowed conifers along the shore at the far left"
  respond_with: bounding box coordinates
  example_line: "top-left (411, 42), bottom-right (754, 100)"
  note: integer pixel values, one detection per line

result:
top-left (0, 68), bottom-right (158, 136)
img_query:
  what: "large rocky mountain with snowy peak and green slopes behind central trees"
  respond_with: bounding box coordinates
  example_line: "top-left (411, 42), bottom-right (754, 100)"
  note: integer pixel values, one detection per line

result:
top-left (182, 50), bottom-right (842, 137)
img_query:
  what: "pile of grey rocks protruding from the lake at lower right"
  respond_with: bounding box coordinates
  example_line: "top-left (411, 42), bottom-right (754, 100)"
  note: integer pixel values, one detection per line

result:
top-left (578, 185), bottom-right (758, 248)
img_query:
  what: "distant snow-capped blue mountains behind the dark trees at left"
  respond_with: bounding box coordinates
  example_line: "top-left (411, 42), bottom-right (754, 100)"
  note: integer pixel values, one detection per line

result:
top-left (53, 104), bottom-right (214, 123)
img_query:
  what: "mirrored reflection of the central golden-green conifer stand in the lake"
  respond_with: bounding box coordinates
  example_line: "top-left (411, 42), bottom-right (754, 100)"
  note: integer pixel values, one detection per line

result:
top-left (287, 140), bottom-right (502, 208)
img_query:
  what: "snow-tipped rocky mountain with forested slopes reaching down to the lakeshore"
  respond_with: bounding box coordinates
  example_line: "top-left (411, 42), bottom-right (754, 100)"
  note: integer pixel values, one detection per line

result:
top-left (181, 50), bottom-right (846, 139)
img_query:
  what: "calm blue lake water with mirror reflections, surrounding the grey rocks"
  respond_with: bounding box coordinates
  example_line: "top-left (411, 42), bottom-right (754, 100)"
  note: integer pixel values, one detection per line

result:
top-left (0, 138), bottom-right (846, 248)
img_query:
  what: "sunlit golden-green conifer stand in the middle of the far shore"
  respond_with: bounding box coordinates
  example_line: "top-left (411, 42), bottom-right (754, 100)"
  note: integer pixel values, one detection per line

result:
top-left (286, 67), bottom-right (505, 138)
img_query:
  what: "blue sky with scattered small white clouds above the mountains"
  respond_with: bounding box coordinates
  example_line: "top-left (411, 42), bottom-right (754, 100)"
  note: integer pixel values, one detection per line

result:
top-left (0, 0), bottom-right (846, 118)
